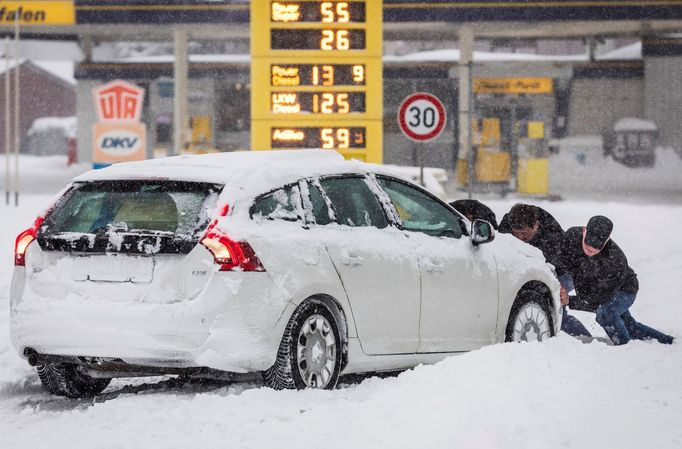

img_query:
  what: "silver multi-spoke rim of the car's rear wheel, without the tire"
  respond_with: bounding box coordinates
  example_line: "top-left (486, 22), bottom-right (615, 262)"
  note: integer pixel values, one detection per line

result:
top-left (296, 314), bottom-right (337, 388)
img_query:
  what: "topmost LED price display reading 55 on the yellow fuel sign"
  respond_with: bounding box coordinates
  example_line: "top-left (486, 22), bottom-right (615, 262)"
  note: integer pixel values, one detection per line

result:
top-left (270, 1), bottom-right (365, 23)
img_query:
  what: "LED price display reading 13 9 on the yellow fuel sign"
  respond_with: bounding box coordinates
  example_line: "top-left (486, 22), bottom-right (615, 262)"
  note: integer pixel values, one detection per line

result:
top-left (270, 64), bottom-right (366, 87)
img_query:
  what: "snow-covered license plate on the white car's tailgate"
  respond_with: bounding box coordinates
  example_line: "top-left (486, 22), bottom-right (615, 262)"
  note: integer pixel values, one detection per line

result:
top-left (72, 255), bottom-right (154, 283)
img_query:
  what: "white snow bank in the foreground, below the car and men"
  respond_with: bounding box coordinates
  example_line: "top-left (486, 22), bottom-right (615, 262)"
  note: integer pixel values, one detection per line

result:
top-left (2, 336), bottom-right (682, 449)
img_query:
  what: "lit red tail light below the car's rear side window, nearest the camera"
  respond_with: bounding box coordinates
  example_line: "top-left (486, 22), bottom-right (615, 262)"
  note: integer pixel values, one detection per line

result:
top-left (201, 229), bottom-right (265, 271)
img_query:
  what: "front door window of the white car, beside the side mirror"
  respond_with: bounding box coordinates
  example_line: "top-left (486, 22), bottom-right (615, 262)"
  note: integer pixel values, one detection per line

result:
top-left (377, 177), bottom-right (463, 238)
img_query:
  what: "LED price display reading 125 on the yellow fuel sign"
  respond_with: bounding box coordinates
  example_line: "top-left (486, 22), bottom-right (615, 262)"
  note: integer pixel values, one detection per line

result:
top-left (270, 92), bottom-right (365, 114)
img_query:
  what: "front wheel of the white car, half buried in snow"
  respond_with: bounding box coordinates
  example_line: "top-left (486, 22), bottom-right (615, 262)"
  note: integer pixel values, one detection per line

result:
top-left (506, 291), bottom-right (554, 342)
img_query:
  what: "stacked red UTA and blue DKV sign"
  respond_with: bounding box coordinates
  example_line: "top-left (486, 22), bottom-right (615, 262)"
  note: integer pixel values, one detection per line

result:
top-left (93, 80), bottom-right (147, 164)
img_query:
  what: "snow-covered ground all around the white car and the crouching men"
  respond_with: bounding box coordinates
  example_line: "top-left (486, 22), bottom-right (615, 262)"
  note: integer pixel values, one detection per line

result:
top-left (0, 155), bottom-right (682, 449)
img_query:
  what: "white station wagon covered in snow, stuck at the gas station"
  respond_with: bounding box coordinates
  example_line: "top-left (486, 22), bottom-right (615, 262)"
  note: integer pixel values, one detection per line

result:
top-left (10, 150), bottom-right (561, 397)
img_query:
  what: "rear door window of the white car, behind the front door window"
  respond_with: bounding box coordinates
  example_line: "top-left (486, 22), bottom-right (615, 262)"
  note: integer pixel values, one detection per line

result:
top-left (320, 177), bottom-right (388, 229)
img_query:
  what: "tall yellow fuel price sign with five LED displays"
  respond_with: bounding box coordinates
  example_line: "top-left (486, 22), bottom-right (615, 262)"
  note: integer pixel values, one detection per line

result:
top-left (251, 0), bottom-right (383, 163)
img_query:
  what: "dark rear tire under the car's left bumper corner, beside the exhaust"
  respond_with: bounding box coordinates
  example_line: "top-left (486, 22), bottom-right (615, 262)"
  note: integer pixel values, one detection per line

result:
top-left (36, 363), bottom-right (111, 399)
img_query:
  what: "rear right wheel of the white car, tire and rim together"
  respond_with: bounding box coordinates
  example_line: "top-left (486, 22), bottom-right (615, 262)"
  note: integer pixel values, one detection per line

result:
top-left (263, 300), bottom-right (342, 390)
